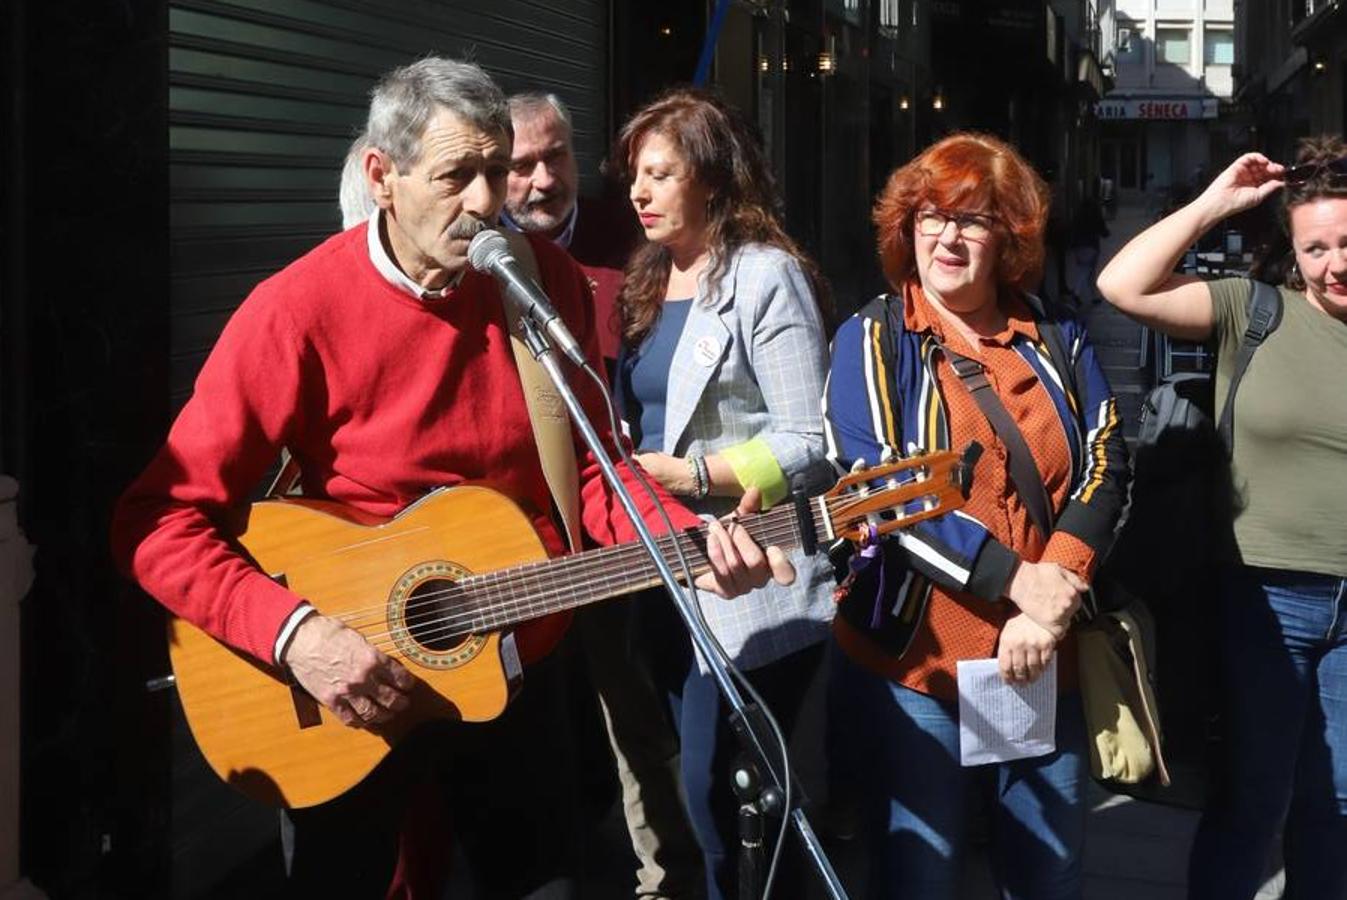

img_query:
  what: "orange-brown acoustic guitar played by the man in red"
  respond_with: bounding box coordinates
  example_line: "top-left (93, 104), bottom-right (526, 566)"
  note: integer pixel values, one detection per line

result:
top-left (168, 451), bottom-right (975, 807)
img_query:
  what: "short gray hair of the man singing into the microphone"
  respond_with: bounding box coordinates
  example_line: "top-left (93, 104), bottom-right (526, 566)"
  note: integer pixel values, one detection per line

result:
top-left (365, 57), bottom-right (515, 170)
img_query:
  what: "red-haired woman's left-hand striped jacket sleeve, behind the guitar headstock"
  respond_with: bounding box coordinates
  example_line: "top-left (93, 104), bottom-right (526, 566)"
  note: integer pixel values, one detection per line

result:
top-left (823, 307), bottom-right (1018, 601)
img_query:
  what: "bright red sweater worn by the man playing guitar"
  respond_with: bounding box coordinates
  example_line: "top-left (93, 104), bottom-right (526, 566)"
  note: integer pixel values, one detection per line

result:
top-left (112, 225), bottom-right (698, 663)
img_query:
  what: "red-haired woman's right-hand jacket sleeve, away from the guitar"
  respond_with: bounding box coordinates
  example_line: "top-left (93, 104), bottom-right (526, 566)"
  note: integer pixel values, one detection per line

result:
top-left (1056, 316), bottom-right (1129, 555)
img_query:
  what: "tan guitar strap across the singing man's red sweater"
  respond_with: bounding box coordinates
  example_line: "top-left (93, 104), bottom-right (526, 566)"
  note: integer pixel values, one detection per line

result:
top-left (267, 229), bottom-right (581, 552)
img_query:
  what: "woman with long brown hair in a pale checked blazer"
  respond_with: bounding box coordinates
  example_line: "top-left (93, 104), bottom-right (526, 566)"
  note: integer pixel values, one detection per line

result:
top-left (614, 89), bottom-right (832, 897)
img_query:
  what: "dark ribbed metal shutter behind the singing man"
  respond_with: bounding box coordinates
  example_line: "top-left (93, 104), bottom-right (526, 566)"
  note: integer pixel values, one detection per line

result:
top-left (168, 0), bottom-right (607, 408)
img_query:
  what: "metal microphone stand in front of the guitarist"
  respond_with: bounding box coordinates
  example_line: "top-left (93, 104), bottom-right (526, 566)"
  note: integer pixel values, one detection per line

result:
top-left (519, 314), bottom-right (847, 900)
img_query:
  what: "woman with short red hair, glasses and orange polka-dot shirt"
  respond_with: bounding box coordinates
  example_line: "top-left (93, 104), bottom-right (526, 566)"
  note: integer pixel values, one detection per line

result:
top-left (824, 133), bottom-right (1127, 899)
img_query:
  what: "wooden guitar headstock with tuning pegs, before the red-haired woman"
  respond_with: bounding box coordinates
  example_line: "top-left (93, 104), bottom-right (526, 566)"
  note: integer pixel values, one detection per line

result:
top-left (822, 442), bottom-right (982, 546)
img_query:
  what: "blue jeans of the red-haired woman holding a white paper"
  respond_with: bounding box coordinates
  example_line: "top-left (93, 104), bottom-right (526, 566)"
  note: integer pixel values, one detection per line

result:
top-left (830, 652), bottom-right (1087, 900)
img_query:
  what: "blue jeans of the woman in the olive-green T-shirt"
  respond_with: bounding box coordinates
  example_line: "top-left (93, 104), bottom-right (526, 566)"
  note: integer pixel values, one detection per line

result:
top-left (1188, 566), bottom-right (1347, 900)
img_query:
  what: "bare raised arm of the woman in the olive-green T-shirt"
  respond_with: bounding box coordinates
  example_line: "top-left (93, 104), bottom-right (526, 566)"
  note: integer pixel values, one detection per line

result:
top-left (1098, 154), bottom-right (1284, 341)
